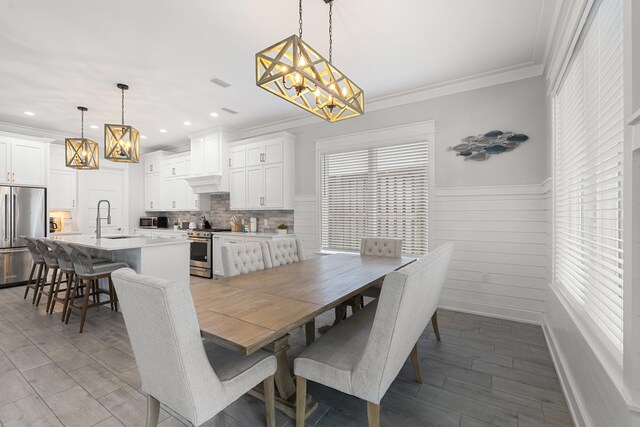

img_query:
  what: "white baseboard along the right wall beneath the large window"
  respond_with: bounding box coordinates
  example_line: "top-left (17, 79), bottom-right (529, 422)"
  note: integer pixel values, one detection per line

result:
top-left (542, 316), bottom-right (595, 426)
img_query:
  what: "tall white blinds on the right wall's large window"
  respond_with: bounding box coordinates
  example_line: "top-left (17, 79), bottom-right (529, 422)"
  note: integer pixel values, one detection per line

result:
top-left (555, 0), bottom-right (624, 354)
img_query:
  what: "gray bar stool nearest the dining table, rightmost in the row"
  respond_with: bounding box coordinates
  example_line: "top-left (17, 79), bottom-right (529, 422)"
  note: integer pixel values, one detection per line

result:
top-left (65, 244), bottom-right (129, 333)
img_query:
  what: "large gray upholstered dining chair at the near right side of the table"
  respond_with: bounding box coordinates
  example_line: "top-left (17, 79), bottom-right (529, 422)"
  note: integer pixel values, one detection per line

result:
top-left (294, 243), bottom-right (453, 427)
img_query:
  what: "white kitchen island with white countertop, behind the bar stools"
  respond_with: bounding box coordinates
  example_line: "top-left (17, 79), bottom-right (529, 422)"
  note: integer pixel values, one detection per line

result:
top-left (48, 235), bottom-right (191, 284)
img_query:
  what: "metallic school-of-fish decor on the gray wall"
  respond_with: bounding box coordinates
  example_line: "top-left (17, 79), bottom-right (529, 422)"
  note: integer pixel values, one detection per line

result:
top-left (448, 130), bottom-right (529, 160)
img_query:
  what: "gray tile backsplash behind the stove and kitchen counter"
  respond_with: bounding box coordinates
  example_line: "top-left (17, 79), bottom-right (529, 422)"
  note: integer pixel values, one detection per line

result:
top-left (159, 193), bottom-right (294, 233)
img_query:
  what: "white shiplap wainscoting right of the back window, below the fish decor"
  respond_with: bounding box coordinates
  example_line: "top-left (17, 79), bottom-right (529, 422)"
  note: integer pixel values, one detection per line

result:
top-left (438, 181), bottom-right (551, 323)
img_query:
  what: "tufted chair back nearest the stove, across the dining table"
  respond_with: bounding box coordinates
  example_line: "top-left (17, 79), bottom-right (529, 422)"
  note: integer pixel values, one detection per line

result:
top-left (222, 242), bottom-right (271, 277)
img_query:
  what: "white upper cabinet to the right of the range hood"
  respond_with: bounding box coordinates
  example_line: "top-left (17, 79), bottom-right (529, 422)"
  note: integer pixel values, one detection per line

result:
top-left (230, 132), bottom-right (295, 210)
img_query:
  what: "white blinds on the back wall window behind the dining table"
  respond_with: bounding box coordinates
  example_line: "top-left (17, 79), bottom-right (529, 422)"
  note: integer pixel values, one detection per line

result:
top-left (320, 141), bottom-right (429, 254)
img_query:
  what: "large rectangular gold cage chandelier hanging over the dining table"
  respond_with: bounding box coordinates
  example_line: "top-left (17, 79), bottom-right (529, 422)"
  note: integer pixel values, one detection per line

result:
top-left (256, 0), bottom-right (364, 122)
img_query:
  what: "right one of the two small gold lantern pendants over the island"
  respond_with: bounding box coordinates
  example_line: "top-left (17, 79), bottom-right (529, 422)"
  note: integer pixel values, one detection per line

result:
top-left (104, 83), bottom-right (140, 163)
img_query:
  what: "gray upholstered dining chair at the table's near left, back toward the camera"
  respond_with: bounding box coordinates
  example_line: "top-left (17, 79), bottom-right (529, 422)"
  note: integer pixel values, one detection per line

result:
top-left (112, 268), bottom-right (276, 427)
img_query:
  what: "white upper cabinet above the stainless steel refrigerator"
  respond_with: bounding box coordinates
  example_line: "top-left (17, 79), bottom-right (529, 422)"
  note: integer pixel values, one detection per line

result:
top-left (0, 136), bottom-right (49, 187)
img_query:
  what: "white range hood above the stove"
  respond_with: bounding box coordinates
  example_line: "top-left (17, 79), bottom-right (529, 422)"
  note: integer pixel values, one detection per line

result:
top-left (187, 130), bottom-right (237, 194)
